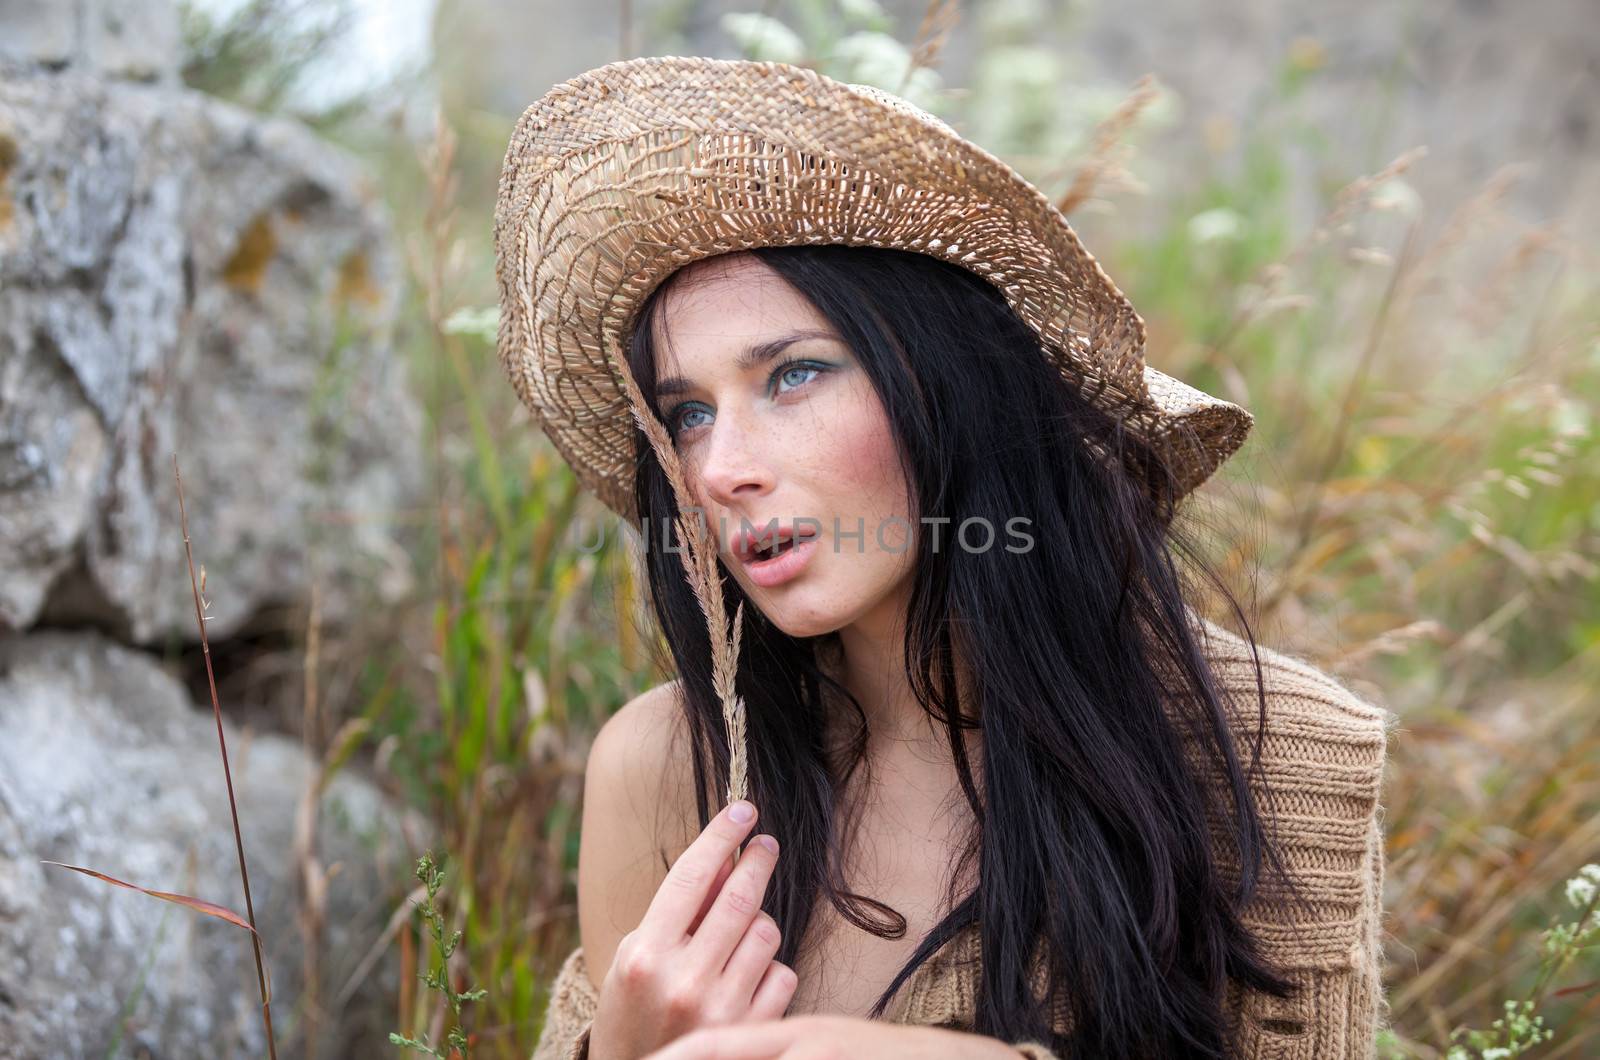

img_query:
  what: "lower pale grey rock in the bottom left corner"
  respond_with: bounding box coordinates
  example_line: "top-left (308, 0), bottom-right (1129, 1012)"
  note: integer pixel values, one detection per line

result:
top-left (0, 632), bottom-right (424, 1058)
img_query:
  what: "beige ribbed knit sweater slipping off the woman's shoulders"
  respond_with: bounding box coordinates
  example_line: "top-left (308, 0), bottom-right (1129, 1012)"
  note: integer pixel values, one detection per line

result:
top-left (533, 623), bottom-right (1397, 1060)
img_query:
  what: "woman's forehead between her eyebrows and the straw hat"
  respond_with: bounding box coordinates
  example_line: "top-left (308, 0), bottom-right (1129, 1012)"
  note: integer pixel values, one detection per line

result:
top-left (653, 253), bottom-right (832, 362)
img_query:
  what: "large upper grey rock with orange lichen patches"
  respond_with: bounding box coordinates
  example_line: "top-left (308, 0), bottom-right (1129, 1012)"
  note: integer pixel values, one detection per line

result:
top-left (0, 72), bottom-right (421, 644)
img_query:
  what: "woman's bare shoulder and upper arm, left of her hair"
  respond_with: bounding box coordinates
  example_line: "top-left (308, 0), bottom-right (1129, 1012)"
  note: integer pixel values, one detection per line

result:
top-left (578, 681), bottom-right (699, 988)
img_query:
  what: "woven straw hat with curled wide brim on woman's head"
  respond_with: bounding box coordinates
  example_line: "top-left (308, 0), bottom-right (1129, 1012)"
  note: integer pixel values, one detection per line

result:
top-left (494, 56), bottom-right (1251, 520)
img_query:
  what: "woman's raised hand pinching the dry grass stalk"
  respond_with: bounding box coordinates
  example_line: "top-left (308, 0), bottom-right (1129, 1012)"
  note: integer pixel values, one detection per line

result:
top-left (589, 799), bottom-right (798, 1060)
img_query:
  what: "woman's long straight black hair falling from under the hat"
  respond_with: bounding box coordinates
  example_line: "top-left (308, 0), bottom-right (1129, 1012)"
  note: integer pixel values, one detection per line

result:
top-left (629, 245), bottom-right (1293, 1057)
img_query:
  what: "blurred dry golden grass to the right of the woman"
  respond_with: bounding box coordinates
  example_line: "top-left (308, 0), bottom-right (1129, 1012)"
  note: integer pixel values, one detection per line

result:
top-left (1164, 128), bottom-right (1600, 1057)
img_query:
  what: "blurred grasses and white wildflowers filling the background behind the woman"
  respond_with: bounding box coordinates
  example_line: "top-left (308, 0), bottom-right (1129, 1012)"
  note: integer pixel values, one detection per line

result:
top-left (168, 0), bottom-right (1600, 1057)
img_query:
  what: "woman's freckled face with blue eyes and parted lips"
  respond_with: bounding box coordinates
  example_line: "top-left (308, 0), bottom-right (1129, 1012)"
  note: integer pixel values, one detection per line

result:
top-left (653, 253), bottom-right (915, 637)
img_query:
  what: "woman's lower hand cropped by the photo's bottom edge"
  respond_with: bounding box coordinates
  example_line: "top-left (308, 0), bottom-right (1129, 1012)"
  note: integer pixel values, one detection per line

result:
top-left (646, 1015), bottom-right (1022, 1060)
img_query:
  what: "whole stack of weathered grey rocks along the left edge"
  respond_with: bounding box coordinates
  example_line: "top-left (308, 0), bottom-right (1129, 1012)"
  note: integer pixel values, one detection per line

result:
top-left (0, 0), bottom-right (427, 1060)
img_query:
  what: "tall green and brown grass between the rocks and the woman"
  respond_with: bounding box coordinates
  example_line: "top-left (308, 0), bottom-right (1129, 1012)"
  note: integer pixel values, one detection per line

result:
top-left (360, 109), bottom-right (661, 1060)
